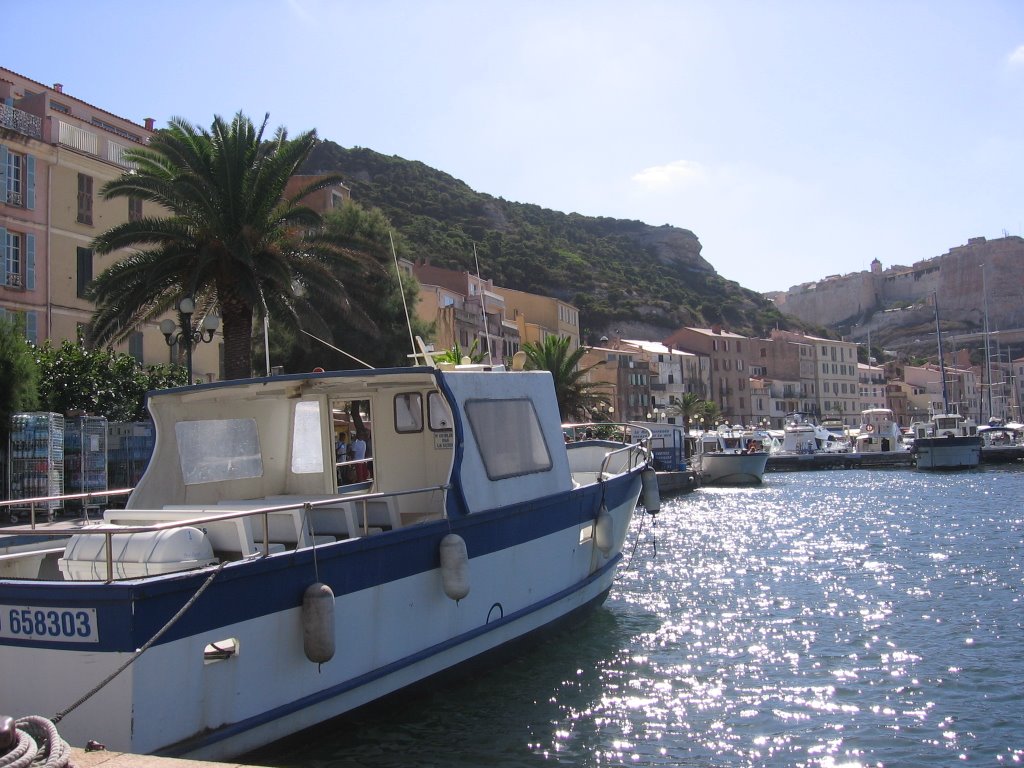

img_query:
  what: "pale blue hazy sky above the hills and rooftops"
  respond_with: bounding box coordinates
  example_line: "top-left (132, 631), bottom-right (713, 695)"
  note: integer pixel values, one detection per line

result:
top-left (8, 0), bottom-right (1024, 292)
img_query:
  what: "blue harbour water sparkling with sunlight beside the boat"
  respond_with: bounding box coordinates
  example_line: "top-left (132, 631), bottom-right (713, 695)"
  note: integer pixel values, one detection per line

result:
top-left (249, 466), bottom-right (1024, 768)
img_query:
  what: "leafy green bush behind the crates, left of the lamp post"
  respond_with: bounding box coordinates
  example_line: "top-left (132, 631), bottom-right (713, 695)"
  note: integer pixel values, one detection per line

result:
top-left (35, 340), bottom-right (188, 421)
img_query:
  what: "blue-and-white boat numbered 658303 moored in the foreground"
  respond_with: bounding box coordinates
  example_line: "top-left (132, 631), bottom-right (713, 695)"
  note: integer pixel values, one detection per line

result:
top-left (0, 365), bottom-right (657, 760)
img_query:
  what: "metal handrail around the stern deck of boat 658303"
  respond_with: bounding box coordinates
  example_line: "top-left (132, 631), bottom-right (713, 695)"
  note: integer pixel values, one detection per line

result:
top-left (0, 483), bottom-right (451, 582)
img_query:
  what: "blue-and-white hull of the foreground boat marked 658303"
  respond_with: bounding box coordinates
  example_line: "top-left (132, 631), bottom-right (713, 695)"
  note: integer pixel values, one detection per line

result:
top-left (0, 470), bottom-right (640, 760)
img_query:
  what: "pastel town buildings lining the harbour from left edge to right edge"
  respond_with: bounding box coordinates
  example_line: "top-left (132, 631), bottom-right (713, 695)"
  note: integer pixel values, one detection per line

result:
top-left (0, 70), bottom-right (1024, 438)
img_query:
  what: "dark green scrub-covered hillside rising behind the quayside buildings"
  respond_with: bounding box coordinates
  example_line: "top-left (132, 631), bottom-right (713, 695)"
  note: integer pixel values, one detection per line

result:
top-left (305, 141), bottom-right (799, 342)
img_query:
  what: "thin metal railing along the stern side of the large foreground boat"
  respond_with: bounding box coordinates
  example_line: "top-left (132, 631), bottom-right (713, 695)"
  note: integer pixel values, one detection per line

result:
top-left (0, 483), bottom-right (451, 582)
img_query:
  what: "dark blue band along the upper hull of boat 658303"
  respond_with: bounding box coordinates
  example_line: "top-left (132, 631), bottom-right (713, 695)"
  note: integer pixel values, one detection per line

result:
top-left (0, 472), bottom-right (639, 652)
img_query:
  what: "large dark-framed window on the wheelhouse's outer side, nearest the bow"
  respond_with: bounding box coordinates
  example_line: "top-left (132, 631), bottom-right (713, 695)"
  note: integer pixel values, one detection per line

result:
top-left (466, 398), bottom-right (551, 480)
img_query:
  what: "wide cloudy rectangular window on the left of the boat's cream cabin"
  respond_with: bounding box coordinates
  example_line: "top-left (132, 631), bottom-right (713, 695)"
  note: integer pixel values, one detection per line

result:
top-left (174, 419), bottom-right (263, 485)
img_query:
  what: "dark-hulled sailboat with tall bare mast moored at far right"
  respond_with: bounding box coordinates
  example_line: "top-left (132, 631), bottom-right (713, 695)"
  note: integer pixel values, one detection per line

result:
top-left (910, 293), bottom-right (981, 469)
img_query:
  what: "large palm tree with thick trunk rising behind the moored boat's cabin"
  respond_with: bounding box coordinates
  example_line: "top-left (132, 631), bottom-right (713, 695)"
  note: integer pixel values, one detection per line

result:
top-left (90, 112), bottom-right (356, 379)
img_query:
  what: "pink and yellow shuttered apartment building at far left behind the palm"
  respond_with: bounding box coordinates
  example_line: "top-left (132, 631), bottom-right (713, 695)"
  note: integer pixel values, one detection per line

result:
top-left (0, 68), bottom-right (222, 380)
